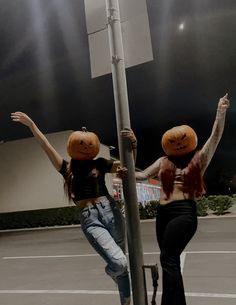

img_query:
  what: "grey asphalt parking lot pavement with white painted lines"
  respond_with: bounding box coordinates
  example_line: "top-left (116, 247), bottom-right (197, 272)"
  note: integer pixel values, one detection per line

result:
top-left (0, 208), bottom-right (236, 305)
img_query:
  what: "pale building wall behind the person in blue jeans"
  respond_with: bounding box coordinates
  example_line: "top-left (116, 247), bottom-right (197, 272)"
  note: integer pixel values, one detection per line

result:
top-left (0, 131), bottom-right (112, 213)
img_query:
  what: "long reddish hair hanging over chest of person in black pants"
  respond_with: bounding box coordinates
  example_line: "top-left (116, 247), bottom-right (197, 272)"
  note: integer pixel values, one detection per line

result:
top-left (160, 151), bottom-right (205, 199)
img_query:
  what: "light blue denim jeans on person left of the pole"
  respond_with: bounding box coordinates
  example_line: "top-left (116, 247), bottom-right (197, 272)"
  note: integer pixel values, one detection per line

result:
top-left (80, 196), bottom-right (130, 305)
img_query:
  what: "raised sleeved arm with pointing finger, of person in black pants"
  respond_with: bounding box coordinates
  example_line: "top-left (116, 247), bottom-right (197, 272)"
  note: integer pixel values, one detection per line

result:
top-left (200, 93), bottom-right (230, 174)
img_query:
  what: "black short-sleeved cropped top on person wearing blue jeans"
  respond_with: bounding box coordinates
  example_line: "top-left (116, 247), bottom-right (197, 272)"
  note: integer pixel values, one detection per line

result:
top-left (59, 158), bottom-right (114, 202)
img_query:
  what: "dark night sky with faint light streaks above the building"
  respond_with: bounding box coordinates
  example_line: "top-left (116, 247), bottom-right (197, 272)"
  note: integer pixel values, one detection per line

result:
top-left (0, 0), bottom-right (236, 192)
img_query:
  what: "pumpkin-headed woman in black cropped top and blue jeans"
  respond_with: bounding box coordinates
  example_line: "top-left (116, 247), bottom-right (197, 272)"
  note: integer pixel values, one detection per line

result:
top-left (11, 112), bottom-right (137, 305)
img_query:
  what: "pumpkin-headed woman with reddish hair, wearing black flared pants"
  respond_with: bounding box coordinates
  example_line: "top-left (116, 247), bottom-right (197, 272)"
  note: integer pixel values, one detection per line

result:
top-left (136, 94), bottom-right (229, 305)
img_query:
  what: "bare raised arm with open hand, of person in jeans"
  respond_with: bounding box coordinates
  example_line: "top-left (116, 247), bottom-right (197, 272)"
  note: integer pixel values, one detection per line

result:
top-left (11, 111), bottom-right (63, 171)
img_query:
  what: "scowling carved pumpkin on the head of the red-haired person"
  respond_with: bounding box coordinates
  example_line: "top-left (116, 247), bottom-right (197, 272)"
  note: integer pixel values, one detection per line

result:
top-left (161, 125), bottom-right (197, 157)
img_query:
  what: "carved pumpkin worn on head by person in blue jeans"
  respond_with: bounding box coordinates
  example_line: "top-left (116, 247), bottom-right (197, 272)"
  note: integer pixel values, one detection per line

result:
top-left (67, 128), bottom-right (100, 160)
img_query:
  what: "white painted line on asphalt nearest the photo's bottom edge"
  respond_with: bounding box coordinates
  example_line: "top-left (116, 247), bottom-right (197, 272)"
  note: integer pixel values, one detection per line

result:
top-left (0, 289), bottom-right (236, 299)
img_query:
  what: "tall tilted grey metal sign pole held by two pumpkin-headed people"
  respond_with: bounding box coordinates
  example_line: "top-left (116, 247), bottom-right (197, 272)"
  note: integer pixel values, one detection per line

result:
top-left (106, 0), bottom-right (147, 305)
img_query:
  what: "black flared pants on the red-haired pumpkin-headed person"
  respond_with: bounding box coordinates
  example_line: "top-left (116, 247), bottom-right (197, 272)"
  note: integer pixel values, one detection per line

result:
top-left (156, 200), bottom-right (197, 305)
